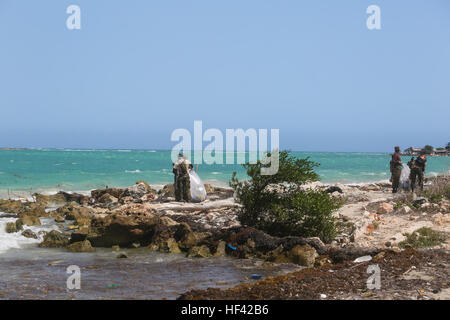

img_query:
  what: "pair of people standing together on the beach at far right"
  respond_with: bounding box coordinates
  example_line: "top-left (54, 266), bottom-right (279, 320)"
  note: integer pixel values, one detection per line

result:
top-left (391, 147), bottom-right (427, 193)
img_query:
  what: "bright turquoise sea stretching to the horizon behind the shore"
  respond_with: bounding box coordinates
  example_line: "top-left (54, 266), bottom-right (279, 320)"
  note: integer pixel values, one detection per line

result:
top-left (0, 149), bottom-right (450, 192)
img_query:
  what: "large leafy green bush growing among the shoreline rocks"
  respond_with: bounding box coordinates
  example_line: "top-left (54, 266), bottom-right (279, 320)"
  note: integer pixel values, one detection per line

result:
top-left (230, 151), bottom-right (342, 242)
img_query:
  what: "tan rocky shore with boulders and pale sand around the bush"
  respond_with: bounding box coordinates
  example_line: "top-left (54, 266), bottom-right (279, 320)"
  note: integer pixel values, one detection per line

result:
top-left (0, 181), bottom-right (450, 299)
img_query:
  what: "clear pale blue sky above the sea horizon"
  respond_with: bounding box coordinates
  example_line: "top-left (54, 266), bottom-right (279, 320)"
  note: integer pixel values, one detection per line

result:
top-left (0, 0), bottom-right (450, 151)
